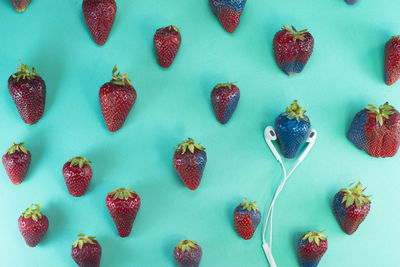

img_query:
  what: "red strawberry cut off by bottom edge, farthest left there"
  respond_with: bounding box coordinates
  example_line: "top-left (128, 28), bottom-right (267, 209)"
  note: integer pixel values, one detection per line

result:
top-left (71, 234), bottom-right (101, 267)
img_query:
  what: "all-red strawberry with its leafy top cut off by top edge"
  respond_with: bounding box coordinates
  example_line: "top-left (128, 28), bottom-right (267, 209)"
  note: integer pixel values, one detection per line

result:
top-left (82, 0), bottom-right (117, 45)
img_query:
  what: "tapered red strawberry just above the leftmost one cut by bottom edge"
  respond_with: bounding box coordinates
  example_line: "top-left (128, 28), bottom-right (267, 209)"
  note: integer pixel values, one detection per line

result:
top-left (106, 188), bottom-right (140, 237)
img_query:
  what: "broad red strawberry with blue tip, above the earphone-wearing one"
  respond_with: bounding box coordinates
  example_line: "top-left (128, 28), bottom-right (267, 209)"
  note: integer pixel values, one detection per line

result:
top-left (273, 25), bottom-right (314, 76)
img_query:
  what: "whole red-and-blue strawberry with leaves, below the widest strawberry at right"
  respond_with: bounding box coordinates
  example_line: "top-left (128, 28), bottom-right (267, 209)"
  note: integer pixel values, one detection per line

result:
top-left (333, 182), bottom-right (371, 235)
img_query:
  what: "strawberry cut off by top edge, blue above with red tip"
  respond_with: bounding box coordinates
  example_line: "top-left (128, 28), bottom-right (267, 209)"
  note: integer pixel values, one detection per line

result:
top-left (208, 0), bottom-right (247, 33)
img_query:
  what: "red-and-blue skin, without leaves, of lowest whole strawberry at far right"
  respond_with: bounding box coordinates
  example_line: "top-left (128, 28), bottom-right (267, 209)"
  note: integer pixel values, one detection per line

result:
top-left (333, 192), bottom-right (371, 235)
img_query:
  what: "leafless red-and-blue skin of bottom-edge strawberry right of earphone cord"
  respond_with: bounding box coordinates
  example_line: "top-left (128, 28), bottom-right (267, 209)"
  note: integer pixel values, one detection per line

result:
top-left (297, 235), bottom-right (328, 267)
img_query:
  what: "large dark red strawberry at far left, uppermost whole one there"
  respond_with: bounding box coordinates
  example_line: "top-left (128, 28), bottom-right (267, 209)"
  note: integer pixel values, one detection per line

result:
top-left (8, 61), bottom-right (46, 125)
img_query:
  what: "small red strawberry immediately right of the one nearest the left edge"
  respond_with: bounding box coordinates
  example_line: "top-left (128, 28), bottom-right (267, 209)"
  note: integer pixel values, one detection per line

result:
top-left (63, 157), bottom-right (92, 197)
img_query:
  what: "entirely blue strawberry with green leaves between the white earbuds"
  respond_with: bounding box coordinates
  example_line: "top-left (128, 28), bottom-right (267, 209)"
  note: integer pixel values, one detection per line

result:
top-left (275, 100), bottom-right (311, 158)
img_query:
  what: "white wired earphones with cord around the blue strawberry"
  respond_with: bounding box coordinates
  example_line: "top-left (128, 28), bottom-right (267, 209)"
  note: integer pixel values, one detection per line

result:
top-left (262, 126), bottom-right (317, 267)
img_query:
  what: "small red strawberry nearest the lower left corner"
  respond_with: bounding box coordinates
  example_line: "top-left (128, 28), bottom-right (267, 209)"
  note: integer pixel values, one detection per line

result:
top-left (18, 205), bottom-right (49, 247)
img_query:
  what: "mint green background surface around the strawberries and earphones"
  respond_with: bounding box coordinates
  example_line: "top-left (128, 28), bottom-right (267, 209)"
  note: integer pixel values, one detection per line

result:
top-left (0, 0), bottom-right (400, 267)
